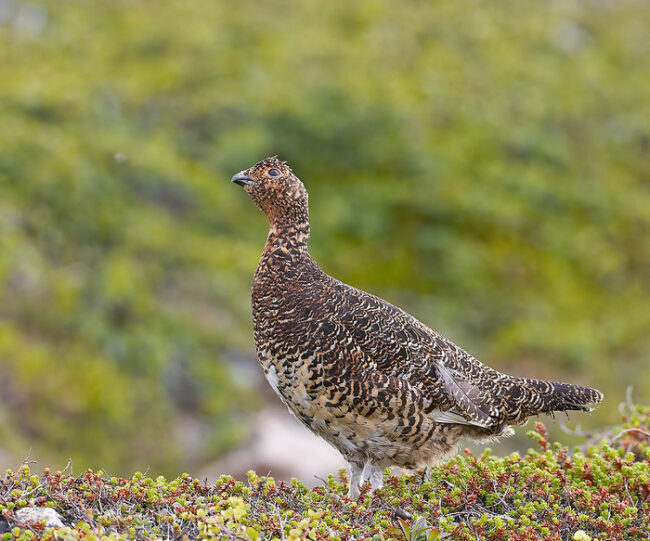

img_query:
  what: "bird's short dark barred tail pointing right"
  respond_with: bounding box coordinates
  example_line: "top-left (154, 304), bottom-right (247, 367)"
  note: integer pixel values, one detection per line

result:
top-left (509, 378), bottom-right (604, 423)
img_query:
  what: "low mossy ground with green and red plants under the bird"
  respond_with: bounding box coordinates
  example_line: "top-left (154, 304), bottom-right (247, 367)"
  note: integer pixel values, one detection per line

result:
top-left (0, 407), bottom-right (650, 541)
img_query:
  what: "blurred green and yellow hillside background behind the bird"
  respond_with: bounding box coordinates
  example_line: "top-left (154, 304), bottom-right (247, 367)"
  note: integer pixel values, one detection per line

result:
top-left (0, 0), bottom-right (650, 475)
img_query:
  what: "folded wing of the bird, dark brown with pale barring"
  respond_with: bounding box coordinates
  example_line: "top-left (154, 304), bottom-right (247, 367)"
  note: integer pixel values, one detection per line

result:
top-left (332, 282), bottom-right (506, 428)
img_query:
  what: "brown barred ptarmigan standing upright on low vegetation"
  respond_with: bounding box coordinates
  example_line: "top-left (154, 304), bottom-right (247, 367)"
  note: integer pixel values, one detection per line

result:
top-left (232, 157), bottom-right (603, 498)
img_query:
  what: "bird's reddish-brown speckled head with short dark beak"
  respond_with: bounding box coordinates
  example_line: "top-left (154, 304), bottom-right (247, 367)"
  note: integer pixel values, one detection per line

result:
top-left (231, 156), bottom-right (308, 224)
